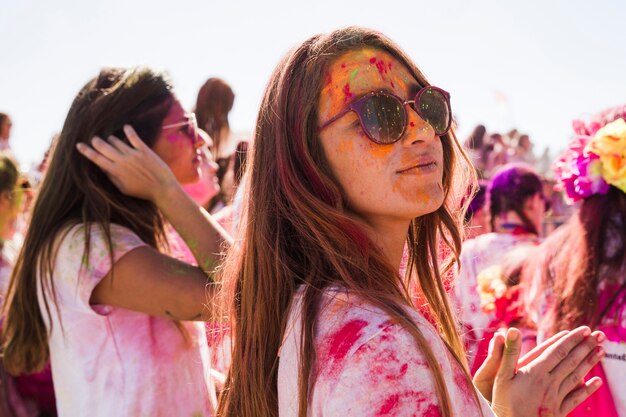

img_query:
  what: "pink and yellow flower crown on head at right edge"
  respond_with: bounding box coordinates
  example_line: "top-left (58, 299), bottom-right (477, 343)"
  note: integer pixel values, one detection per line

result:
top-left (553, 119), bottom-right (626, 203)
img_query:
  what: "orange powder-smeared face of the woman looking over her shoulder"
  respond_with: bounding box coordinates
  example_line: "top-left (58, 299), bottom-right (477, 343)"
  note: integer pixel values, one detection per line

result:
top-left (318, 48), bottom-right (444, 226)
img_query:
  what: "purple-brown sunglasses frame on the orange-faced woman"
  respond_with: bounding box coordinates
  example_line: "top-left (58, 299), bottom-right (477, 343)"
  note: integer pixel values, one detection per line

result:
top-left (319, 85), bottom-right (452, 145)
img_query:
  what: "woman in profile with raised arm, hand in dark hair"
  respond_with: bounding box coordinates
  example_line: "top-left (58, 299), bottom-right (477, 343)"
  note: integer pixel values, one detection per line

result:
top-left (3, 68), bottom-right (229, 416)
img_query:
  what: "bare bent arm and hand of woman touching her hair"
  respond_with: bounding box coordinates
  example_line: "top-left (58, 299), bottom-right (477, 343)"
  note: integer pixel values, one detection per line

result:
top-left (77, 126), bottom-right (232, 320)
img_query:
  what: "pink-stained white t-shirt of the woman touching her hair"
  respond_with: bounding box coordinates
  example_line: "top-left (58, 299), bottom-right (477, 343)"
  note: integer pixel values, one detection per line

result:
top-left (38, 225), bottom-right (215, 417)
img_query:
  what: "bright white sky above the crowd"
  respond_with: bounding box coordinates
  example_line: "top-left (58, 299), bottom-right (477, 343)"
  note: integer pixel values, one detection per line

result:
top-left (0, 0), bottom-right (626, 168)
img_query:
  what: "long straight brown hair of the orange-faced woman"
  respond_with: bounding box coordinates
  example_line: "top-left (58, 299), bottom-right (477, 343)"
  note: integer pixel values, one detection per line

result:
top-left (218, 27), bottom-right (478, 417)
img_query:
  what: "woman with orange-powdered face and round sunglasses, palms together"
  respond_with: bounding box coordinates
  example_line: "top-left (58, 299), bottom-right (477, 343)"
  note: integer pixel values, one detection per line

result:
top-left (83, 28), bottom-right (599, 417)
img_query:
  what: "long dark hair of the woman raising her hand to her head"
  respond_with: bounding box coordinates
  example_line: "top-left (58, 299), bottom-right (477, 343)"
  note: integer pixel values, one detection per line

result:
top-left (2, 68), bottom-right (173, 374)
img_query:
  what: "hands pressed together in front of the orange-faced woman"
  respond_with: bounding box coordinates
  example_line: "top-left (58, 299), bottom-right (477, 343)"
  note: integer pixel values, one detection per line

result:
top-left (474, 327), bottom-right (605, 417)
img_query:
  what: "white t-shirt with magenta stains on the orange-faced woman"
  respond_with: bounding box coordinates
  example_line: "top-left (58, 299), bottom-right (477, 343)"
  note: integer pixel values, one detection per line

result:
top-left (278, 289), bottom-right (494, 417)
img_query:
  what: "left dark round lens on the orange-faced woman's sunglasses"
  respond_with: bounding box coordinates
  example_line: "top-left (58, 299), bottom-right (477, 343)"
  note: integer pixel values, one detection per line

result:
top-left (361, 94), bottom-right (406, 144)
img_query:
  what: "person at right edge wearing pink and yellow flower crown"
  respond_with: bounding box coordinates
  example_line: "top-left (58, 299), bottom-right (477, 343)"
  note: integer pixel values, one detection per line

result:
top-left (527, 105), bottom-right (626, 417)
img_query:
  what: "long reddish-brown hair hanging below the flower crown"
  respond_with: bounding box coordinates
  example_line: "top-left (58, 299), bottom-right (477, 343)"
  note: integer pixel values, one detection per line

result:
top-left (536, 187), bottom-right (626, 334)
